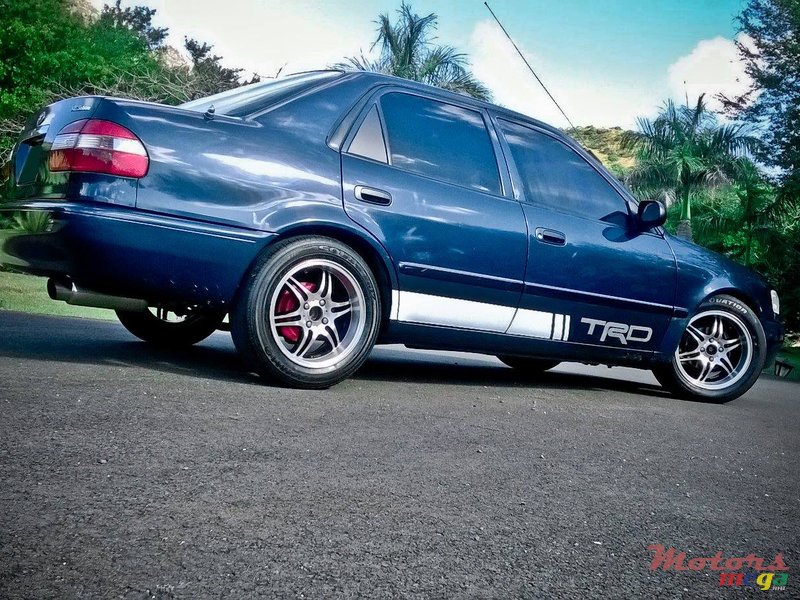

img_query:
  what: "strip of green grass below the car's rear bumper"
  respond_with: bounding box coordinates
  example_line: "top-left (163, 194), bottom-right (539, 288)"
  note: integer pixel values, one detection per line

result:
top-left (0, 270), bottom-right (117, 319)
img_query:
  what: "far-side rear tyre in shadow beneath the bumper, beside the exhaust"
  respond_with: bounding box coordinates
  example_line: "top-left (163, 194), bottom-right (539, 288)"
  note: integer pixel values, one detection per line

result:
top-left (116, 308), bottom-right (225, 348)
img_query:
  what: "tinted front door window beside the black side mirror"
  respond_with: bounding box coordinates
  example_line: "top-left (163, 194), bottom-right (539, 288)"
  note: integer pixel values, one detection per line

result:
top-left (499, 120), bottom-right (627, 219)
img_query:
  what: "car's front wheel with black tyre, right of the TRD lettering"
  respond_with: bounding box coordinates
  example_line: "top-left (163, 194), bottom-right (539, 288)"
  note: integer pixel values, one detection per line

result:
top-left (653, 295), bottom-right (766, 403)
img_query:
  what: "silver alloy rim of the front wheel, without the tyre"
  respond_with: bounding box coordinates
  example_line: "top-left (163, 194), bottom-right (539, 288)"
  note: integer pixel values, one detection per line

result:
top-left (675, 310), bottom-right (754, 390)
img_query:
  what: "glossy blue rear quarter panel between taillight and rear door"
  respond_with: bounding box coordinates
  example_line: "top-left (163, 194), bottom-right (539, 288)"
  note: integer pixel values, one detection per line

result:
top-left (95, 76), bottom-right (368, 231)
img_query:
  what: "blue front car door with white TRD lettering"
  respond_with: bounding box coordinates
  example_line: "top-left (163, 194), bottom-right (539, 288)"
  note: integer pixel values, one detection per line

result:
top-left (496, 118), bottom-right (676, 351)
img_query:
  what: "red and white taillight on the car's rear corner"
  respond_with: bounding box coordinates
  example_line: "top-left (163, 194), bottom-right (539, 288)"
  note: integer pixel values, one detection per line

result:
top-left (50, 119), bottom-right (150, 177)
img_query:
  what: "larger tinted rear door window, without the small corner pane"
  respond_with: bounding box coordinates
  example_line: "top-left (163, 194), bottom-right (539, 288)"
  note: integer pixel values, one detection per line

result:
top-left (381, 93), bottom-right (500, 194)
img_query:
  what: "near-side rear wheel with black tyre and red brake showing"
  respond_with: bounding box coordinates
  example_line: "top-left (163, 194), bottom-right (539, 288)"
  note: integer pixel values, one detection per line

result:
top-left (231, 236), bottom-right (381, 389)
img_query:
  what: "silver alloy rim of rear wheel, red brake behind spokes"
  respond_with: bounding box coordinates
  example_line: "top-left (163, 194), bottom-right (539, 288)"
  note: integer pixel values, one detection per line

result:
top-left (268, 259), bottom-right (366, 370)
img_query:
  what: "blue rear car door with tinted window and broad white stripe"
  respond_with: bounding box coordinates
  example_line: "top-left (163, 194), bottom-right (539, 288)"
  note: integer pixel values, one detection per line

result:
top-left (342, 89), bottom-right (528, 333)
